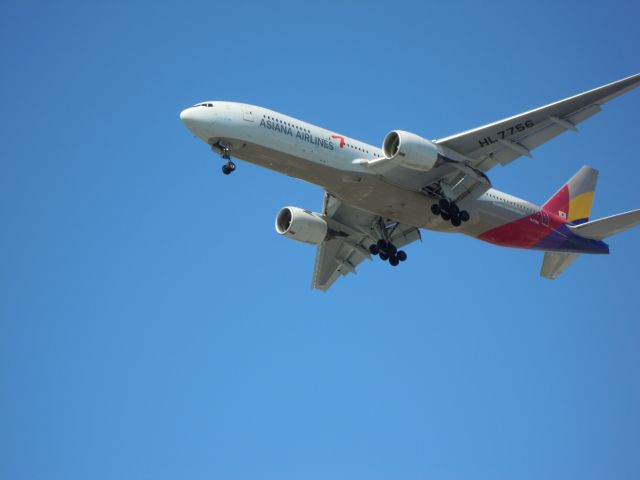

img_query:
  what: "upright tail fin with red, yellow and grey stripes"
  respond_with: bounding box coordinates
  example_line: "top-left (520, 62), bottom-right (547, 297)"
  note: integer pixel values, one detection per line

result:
top-left (542, 165), bottom-right (598, 224)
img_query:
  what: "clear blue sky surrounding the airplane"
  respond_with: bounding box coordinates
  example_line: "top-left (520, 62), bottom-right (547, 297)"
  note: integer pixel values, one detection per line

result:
top-left (0, 0), bottom-right (640, 480)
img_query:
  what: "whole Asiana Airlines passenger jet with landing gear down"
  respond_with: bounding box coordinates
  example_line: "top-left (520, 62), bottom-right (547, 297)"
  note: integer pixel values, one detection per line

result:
top-left (180, 74), bottom-right (640, 291)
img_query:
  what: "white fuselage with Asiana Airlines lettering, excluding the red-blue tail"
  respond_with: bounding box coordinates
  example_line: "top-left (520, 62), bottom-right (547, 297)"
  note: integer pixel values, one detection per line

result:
top-left (181, 101), bottom-right (539, 237)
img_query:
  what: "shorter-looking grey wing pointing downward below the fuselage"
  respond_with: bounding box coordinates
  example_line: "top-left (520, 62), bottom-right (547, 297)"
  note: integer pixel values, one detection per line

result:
top-left (312, 193), bottom-right (420, 291)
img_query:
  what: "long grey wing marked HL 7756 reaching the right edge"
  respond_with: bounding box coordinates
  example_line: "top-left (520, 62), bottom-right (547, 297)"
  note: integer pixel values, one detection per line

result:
top-left (435, 74), bottom-right (640, 172)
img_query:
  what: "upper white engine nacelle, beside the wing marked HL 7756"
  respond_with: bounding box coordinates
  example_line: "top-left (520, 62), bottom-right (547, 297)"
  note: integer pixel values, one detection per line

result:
top-left (382, 130), bottom-right (440, 172)
